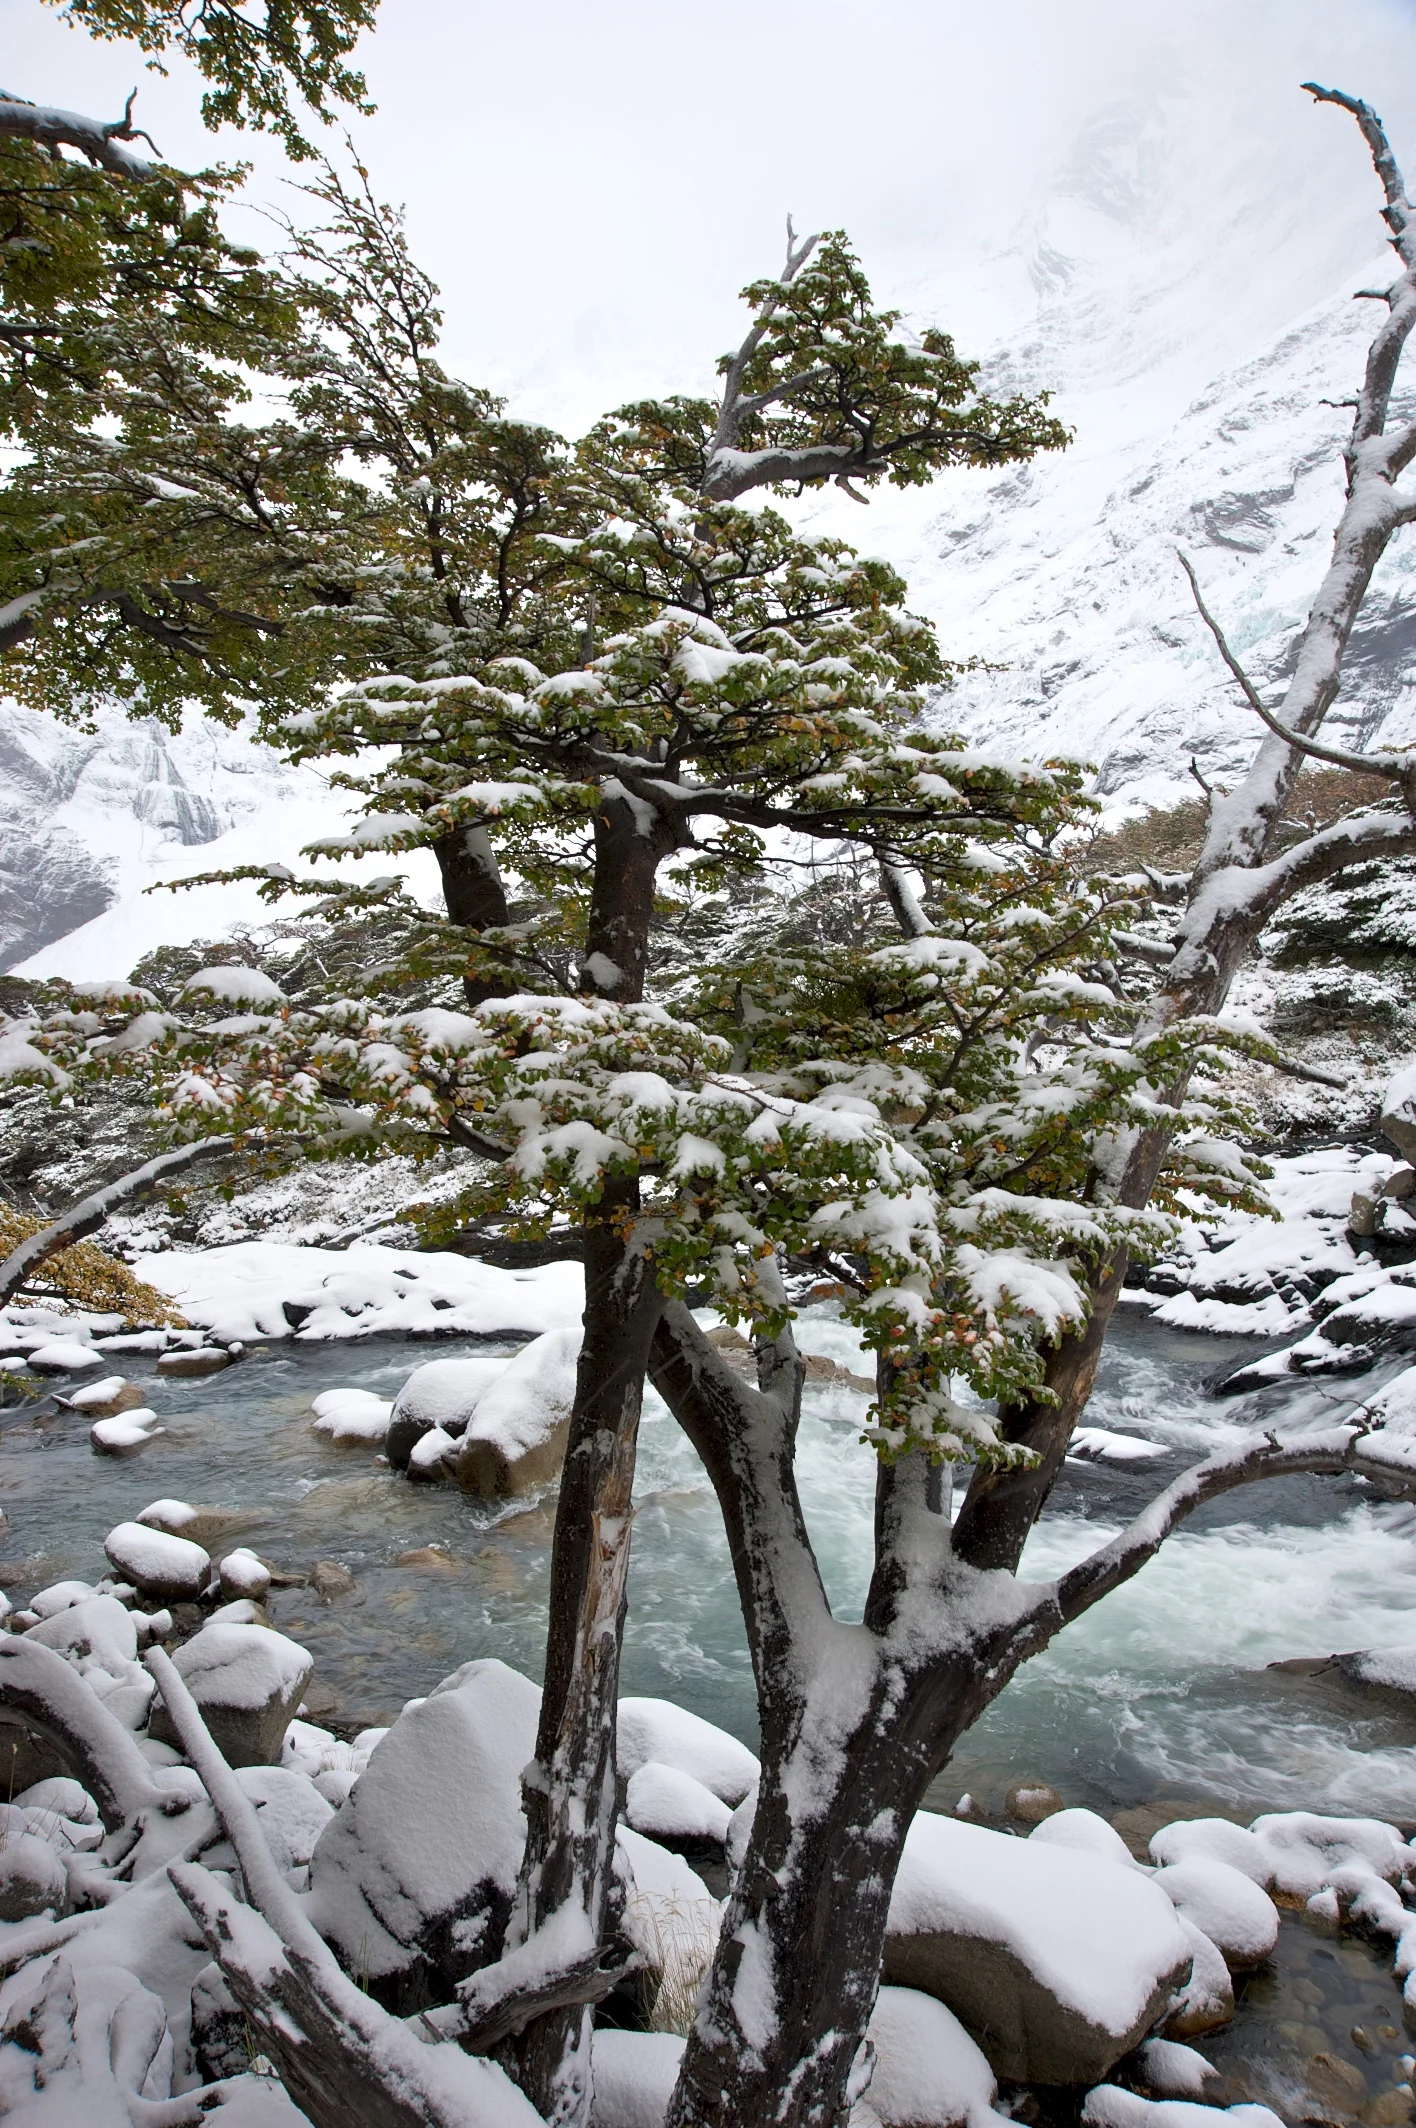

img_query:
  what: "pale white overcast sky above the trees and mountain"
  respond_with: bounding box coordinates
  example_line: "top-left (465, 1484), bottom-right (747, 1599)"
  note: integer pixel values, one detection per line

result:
top-left (0, 0), bottom-right (1416, 426)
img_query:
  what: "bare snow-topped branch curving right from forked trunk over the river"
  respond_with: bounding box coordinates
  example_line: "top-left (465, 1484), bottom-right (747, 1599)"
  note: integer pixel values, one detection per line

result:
top-left (1056, 1426), bottom-right (1416, 1624)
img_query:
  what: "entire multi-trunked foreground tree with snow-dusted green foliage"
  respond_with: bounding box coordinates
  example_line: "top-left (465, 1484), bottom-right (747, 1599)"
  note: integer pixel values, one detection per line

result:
top-left (6, 92), bottom-right (1416, 2128)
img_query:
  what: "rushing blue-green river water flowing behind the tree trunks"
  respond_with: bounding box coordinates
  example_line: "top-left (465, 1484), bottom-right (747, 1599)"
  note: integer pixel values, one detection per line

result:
top-left (0, 1307), bottom-right (1416, 1824)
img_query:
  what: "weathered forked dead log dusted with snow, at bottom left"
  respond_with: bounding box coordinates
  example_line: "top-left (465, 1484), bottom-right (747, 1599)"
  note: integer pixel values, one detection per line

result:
top-left (145, 1647), bottom-right (541, 2128)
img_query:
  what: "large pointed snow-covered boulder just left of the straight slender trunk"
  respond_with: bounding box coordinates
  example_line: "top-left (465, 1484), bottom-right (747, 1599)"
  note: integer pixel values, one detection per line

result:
top-left (309, 1660), bottom-right (541, 2002)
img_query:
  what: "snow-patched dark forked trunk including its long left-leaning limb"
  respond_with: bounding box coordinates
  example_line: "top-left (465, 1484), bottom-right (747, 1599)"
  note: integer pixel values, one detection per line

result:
top-left (652, 1307), bottom-right (1039, 2128)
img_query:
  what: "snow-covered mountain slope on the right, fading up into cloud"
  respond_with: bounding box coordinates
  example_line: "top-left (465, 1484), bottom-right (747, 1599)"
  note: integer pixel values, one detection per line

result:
top-left (809, 96), bottom-right (1416, 802)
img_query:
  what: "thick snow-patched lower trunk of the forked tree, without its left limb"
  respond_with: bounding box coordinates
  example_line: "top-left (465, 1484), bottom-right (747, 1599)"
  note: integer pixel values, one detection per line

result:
top-left (669, 1456), bottom-right (1033, 2128)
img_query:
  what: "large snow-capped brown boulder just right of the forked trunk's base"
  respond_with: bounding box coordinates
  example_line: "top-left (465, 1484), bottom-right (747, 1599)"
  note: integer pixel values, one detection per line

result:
top-left (884, 1813), bottom-right (1192, 2083)
